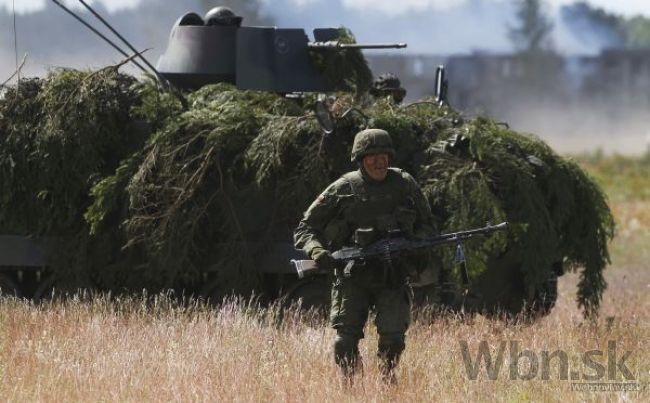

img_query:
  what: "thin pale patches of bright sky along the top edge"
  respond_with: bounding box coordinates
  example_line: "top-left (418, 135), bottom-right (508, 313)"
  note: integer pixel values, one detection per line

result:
top-left (0, 0), bottom-right (650, 17)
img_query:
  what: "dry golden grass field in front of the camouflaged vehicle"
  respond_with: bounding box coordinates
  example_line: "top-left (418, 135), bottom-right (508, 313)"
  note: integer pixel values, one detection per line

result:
top-left (0, 156), bottom-right (650, 402)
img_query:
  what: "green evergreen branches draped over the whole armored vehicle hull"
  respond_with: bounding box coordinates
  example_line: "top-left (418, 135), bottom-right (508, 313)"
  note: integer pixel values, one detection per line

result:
top-left (0, 59), bottom-right (614, 313)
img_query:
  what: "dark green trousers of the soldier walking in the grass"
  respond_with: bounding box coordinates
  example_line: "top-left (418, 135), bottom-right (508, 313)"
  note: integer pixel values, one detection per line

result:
top-left (330, 268), bottom-right (412, 374)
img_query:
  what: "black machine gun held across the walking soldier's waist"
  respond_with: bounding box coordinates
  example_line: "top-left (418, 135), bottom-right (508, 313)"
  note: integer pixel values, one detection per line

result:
top-left (291, 222), bottom-right (508, 283)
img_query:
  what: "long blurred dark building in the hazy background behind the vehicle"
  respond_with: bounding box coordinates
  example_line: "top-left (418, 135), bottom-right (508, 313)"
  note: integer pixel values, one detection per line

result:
top-left (368, 49), bottom-right (650, 111)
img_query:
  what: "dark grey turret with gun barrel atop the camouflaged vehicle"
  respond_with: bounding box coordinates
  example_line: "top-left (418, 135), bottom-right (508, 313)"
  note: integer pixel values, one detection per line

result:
top-left (157, 7), bottom-right (406, 93)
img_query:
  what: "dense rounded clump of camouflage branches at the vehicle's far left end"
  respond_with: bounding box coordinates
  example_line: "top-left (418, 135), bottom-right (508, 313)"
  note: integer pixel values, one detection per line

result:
top-left (0, 67), bottom-right (173, 283)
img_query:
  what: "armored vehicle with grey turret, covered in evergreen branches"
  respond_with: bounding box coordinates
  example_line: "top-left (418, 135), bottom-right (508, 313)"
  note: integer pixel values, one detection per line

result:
top-left (0, 4), bottom-right (613, 316)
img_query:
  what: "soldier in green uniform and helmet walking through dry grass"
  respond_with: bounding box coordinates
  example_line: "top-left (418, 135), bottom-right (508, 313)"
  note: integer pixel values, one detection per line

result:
top-left (294, 129), bottom-right (433, 382)
